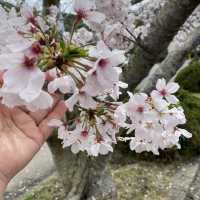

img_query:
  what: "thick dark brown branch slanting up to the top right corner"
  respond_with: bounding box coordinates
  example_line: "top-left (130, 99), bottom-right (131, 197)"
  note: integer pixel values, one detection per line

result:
top-left (124, 0), bottom-right (200, 89)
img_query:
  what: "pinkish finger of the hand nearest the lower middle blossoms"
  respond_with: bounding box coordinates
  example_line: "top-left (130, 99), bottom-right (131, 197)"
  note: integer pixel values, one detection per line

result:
top-left (39, 101), bottom-right (67, 139)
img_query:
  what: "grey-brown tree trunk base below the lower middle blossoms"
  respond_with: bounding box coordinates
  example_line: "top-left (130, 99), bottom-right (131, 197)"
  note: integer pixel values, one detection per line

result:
top-left (48, 136), bottom-right (117, 200)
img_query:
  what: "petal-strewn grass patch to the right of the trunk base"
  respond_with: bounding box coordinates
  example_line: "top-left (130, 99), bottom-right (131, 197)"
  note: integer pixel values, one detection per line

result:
top-left (112, 162), bottom-right (173, 200)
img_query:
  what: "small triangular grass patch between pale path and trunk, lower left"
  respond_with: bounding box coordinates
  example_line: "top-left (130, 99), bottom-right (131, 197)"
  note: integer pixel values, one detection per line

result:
top-left (19, 176), bottom-right (65, 200)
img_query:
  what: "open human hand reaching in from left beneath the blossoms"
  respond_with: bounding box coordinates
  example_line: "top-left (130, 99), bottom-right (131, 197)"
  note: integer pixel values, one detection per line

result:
top-left (0, 101), bottom-right (66, 194)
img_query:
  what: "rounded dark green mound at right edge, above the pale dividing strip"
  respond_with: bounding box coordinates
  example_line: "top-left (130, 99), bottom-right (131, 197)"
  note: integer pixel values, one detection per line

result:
top-left (176, 60), bottom-right (200, 93)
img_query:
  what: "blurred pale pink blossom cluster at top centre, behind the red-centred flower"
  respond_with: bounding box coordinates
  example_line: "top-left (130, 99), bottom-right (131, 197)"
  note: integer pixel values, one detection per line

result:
top-left (89, 0), bottom-right (133, 50)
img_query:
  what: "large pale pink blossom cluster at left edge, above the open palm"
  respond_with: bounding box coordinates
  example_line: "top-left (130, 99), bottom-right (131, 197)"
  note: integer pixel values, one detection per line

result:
top-left (0, 5), bottom-right (53, 110)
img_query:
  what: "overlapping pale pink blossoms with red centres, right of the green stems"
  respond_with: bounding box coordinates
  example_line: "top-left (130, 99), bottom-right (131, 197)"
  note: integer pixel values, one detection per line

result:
top-left (85, 41), bottom-right (125, 96)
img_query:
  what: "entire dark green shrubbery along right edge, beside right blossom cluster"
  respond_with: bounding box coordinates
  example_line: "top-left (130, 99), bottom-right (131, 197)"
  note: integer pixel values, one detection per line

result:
top-left (175, 60), bottom-right (200, 155)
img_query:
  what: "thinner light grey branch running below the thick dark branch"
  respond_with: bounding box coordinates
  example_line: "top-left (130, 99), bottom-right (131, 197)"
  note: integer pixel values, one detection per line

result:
top-left (136, 27), bottom-right (200, 92)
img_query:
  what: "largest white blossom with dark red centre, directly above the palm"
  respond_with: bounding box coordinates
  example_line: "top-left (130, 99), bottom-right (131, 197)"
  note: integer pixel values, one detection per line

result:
top-left (0, 53), bottom-right (52, 108)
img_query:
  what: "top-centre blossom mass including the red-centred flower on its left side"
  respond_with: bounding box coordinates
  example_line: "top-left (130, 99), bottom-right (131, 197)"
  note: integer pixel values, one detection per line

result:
top-left (65, 0), bottom-right (136, 51)
